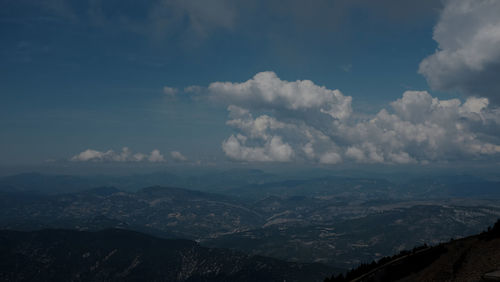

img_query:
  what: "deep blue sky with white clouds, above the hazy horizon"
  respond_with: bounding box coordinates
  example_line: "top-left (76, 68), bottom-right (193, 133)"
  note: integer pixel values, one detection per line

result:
top-left (0, 0), bottom-right (500, 167)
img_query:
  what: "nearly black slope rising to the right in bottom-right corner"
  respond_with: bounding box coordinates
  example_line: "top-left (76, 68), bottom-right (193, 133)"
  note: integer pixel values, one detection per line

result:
top-left (325, 220), bottom-right (500, 282)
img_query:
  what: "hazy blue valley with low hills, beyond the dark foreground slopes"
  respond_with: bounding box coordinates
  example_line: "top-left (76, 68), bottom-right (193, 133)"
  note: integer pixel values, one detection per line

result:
top-left (0, 171), bottom-right (500, 269)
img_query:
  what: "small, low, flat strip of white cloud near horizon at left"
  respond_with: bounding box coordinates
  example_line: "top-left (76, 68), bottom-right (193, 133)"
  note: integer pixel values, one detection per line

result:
top-left (70, 147), bottom-right (165, 162)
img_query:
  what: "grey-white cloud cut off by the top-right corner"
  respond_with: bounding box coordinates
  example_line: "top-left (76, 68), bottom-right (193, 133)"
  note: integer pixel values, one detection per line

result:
top-left (419, 0), bottom-right (500, 103)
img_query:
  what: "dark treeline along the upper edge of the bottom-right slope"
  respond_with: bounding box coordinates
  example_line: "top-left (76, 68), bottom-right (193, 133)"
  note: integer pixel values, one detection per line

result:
top-left (325, 219), bottom-right (500, 282)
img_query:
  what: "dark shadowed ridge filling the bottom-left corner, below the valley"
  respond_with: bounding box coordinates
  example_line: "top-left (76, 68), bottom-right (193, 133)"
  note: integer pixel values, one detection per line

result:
top-left (0, 229), bottom-right (332, 281)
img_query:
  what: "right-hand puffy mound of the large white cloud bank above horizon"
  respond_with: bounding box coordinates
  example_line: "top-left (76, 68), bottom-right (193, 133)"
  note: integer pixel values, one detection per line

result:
top-left (338, 91), bottom-right (500, 163)
